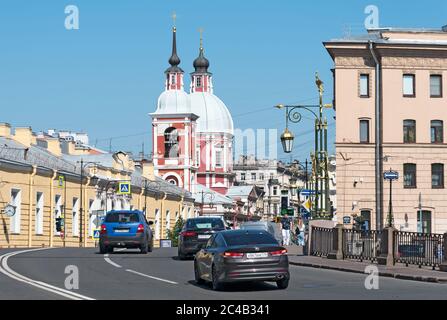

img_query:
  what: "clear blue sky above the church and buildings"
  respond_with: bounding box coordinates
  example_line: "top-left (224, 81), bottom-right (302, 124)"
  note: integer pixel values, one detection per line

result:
top-left (0, 0), bottom-right (447, 160)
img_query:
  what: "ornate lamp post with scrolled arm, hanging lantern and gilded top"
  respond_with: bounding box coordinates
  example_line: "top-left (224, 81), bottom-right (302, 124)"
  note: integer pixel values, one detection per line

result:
top-left (276, 73), bottom-right (332, 219)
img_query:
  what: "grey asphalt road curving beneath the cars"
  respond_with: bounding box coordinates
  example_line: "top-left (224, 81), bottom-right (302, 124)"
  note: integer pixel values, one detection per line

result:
top-left (0, 249), bottom-right (447, 300)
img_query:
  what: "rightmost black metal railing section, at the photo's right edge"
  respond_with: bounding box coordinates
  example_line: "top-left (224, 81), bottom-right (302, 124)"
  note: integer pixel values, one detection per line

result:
top-left (394, 232), bottom-right (444, 269)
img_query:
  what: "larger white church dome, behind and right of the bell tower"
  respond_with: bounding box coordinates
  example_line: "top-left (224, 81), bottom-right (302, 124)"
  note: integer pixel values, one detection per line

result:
top-left (189, 92), bottom-right (234, 135)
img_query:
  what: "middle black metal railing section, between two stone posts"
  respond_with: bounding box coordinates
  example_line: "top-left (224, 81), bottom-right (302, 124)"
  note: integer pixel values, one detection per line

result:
top-left (343, 230), bottom-right (382, 262)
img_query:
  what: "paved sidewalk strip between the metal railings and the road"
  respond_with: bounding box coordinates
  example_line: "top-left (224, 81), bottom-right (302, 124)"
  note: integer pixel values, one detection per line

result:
top-left (287, 246), bottom-right (447, 284)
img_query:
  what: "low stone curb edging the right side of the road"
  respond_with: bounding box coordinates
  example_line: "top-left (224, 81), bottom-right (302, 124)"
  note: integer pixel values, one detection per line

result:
top-left (289, 262), bottom-right (447, 284)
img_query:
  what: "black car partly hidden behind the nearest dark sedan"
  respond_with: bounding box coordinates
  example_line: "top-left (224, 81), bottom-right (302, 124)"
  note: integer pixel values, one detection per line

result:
top-left (178, 217), bottom-right (228, 260)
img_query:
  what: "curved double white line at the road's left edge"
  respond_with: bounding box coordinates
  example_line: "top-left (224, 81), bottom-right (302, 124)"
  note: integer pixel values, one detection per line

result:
top-left (0, 248), bottom-right (95, 300)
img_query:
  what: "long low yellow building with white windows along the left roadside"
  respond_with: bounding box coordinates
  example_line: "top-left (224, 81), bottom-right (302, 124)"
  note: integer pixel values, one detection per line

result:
top-left (0, 123), bottom-right (195, 249)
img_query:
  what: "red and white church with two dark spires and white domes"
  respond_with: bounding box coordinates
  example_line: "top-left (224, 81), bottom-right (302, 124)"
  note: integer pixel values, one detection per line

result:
top-left (151, 27), bottom-right (234, 195)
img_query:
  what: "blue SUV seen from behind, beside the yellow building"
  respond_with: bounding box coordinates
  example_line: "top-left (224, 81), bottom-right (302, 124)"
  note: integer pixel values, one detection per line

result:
top-left (99, 211), bottom-right (154, 254)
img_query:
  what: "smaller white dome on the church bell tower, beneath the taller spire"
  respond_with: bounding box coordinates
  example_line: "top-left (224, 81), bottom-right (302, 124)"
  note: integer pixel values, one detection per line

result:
top-left (155, 90), bottom-right (191, 114)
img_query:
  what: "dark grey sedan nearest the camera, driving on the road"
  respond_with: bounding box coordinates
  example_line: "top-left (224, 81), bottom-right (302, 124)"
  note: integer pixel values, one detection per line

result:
top-left (194, 230), bottom-right (290, 290)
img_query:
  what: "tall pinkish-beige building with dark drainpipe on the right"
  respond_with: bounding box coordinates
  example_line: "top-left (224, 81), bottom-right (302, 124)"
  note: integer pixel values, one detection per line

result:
top-left (324, 27), bottom-right (447, 233)
